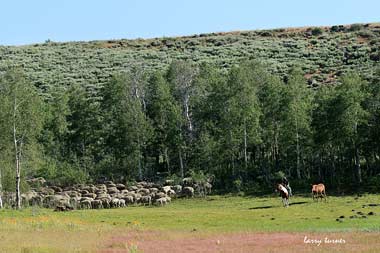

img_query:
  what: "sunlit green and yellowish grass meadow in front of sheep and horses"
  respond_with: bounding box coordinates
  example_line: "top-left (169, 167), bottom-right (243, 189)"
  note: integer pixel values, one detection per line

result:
top-left (0, 195), bottom-right (380, 252)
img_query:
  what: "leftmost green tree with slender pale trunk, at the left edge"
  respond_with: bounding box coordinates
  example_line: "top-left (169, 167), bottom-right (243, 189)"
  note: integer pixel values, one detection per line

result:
top-left (0, 69), bottom-right (44, 196)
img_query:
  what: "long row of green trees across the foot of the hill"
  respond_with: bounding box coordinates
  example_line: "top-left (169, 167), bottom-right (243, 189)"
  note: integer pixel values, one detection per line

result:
top-left (0, 61), bottom-right (380, 196)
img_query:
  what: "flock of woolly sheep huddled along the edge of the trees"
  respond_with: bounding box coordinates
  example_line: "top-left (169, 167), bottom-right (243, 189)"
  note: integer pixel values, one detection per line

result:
top-left (4, 178), bottom-right (212, 211)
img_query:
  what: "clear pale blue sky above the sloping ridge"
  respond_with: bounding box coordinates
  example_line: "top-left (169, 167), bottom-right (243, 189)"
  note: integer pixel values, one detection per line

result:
top-left (0, 0), bottom-right (380, 45)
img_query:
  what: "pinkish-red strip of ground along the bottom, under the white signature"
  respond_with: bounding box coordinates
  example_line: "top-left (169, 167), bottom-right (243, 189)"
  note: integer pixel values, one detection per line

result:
top-left (100, 231), bottom-right (380, 253)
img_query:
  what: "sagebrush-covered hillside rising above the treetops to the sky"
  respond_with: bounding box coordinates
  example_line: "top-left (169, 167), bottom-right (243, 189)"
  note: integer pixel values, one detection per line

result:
top-left (0, 23), bottom-right (380, 95)
